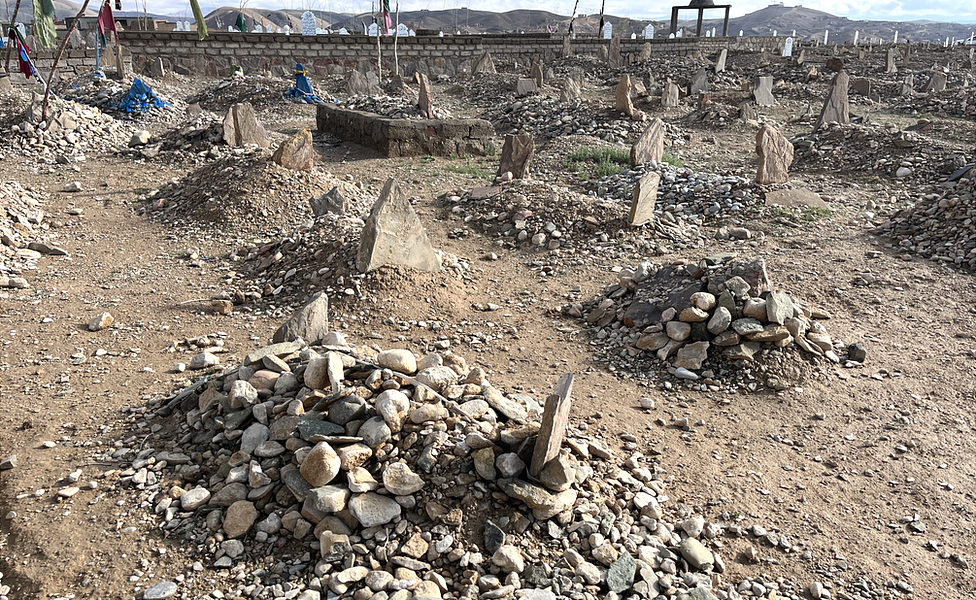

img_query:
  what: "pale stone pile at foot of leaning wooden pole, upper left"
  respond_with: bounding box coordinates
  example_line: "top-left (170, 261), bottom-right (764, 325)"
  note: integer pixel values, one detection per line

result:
top-left (6, 97), bottom-right (131, 165)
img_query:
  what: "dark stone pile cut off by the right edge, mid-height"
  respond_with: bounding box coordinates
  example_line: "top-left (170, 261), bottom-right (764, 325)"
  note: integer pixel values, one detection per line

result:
top-left (879, 161), bottom-right (976, 270)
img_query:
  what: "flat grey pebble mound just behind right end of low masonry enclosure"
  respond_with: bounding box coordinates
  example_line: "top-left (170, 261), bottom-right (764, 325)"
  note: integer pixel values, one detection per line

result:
top-left (480, 96), bottom-right (645, 142)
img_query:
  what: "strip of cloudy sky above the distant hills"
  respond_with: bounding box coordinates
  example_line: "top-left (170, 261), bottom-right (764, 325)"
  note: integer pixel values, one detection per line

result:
top-left (152, 0), bottom-right (976, 23)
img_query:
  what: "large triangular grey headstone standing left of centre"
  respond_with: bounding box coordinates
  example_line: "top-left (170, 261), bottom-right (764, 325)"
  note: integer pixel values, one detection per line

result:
top-left (356, 179), bottom-right (441, 273)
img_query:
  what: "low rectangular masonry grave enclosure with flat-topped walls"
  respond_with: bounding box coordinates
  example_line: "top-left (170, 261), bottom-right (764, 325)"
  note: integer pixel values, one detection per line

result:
top-left (315, 104), bottom-right (495, 157)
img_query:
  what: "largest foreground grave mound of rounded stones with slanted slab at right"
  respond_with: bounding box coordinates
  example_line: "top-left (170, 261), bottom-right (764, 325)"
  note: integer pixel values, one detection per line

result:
top-left (114, 332), bottom-right (735, 600)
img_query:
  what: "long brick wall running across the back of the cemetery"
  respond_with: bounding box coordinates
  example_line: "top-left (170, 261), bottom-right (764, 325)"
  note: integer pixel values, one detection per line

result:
top-left (121, 31), bottom-right (785, 76)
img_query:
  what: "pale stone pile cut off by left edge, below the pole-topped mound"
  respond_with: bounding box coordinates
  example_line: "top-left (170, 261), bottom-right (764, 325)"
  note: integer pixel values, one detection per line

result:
top-left (0, 181), bottom-right (68, 289)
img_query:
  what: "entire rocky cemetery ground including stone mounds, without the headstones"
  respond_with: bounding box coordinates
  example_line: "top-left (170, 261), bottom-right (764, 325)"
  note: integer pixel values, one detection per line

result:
top-left (0, 39), bottom-right (976, 600)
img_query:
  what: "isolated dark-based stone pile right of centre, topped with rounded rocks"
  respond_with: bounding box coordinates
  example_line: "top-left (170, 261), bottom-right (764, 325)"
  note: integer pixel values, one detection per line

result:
top-left (561, 252), bottom-right (865, 391)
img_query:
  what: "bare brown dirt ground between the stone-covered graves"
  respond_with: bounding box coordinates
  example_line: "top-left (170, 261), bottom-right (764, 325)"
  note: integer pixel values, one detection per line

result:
top-left (0, 58), bottom-right (976, 598)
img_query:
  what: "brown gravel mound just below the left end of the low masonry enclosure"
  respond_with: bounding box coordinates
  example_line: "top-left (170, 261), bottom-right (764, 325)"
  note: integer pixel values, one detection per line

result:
top-left (144, 147), bottom-right (338, 232)
